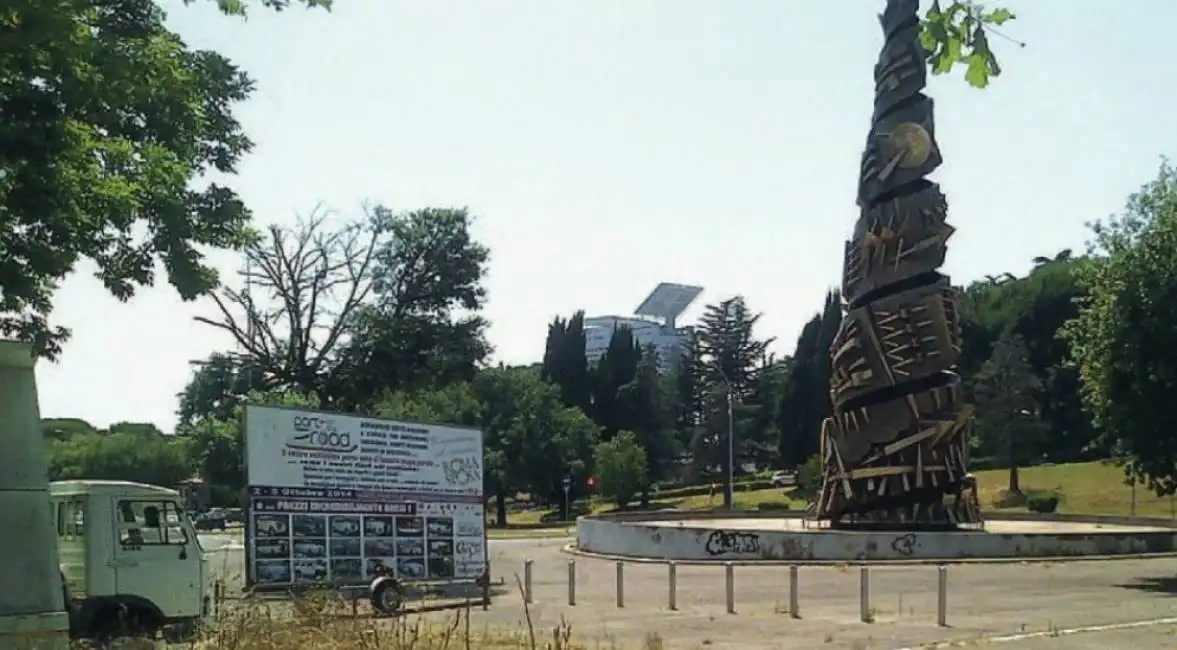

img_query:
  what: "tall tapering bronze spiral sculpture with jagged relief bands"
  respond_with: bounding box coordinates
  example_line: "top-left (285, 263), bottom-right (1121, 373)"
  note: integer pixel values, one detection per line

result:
top-left (812, 0), bottom-right (980, 530)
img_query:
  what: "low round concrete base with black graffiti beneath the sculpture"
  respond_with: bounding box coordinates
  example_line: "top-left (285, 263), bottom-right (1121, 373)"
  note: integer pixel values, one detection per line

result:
top-left (577, 512), bottom-right (1177, 562)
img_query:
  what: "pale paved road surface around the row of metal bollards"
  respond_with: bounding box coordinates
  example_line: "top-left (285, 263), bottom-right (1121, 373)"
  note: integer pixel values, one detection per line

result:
top-left (202, 539), bottom-right (1177, 650)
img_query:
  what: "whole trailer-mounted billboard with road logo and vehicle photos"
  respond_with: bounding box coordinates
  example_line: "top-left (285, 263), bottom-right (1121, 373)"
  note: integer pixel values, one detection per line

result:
top-left (245, 405), bottom-right (486, 585)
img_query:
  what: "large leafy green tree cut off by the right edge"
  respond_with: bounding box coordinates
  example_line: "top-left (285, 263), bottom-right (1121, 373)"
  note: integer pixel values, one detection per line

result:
top-left (1065, 161), bottom-right (1177, 495)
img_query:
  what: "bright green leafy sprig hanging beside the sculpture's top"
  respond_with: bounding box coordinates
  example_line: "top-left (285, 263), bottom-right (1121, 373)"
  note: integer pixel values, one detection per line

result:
top-left (919, 0), bottom-right (1024, 88)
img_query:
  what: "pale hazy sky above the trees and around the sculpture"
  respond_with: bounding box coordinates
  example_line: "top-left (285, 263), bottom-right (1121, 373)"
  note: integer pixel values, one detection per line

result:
top-left (29, 0), bottom-right (1177, 431)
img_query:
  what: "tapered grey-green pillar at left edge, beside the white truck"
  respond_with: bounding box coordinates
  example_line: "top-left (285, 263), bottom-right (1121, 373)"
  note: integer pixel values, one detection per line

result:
top-left (0, 340), bottom-right (69, 650)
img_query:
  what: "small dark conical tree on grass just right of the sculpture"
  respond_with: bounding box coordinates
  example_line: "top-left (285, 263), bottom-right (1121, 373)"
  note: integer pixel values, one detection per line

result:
top-left (973, 331), bottom-right (1042, 495)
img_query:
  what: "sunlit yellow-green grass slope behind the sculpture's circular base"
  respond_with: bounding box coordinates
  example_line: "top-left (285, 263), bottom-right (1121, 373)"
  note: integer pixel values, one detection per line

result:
top-left (501, 460), bottom-right (1177, 525)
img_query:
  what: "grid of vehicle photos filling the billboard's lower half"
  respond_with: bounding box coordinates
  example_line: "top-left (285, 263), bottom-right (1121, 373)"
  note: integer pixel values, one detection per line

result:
top-left (253, 503), bottom-right (485, 583)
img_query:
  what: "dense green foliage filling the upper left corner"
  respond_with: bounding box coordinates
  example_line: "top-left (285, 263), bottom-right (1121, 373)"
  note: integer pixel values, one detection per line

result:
top-left (0, 0), bottom-right (298, 358)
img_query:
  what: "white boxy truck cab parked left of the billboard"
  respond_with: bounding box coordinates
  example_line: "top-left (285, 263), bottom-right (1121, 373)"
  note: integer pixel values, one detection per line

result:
top-left (49, 480), bottom-right (211, 638)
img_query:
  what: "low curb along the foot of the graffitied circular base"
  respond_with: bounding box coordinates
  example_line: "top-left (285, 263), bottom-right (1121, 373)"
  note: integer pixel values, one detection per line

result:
top-left (560, 544), bottom-right (1177, 566)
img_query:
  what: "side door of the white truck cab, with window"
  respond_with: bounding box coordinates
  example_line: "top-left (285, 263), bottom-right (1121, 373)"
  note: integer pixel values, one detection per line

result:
top-left (114, 498), bottom-right (204, 619)
